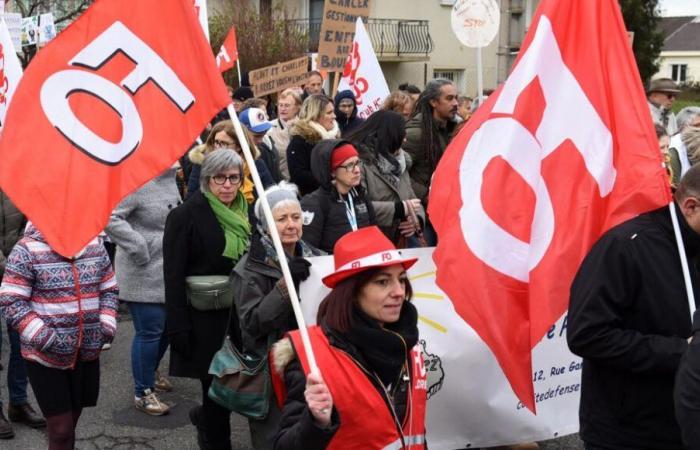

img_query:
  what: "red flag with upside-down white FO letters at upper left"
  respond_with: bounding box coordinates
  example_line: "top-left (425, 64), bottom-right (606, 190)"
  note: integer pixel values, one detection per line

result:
top-left (0, 0), bottom-right (230, 256)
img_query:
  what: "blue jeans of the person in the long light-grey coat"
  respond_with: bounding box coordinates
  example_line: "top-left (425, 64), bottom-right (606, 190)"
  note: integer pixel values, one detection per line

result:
top-left (127, 302), bottom-right (168, 397)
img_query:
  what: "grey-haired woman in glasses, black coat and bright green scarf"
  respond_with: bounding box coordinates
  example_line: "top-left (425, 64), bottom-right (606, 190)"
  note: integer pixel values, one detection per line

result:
top-left (163, 149), bottom-right (251, 449)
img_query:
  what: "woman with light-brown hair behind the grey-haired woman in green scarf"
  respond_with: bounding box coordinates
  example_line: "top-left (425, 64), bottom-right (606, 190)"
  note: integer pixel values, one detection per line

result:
top-left (187, 120), bottom-right (275, 201)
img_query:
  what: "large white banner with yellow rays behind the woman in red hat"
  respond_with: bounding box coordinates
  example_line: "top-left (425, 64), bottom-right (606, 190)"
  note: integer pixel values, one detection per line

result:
top-left (300, 248), bottom-right (581, 449)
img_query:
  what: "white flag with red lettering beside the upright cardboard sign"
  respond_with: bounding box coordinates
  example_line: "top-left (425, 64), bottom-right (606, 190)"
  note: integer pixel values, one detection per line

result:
top-left (338, 17), bottom-right (389, 119)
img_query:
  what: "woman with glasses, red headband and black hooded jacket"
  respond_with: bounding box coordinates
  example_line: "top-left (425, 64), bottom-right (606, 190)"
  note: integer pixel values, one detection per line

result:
top-left (301, 139), bottom-right (375, 253)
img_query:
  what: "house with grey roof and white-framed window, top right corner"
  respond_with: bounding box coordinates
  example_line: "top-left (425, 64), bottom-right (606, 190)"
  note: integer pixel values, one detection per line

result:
top-left (654, 16), bottom-right (700, 84)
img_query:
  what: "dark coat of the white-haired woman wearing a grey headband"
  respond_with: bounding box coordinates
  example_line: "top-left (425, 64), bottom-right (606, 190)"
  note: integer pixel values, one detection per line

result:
top-left (231, 233), bottom-right (323, 356)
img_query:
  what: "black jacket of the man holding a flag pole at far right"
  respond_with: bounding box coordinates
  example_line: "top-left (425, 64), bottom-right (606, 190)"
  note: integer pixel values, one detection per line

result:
top-left (567, 207), bottom-right (700, 450)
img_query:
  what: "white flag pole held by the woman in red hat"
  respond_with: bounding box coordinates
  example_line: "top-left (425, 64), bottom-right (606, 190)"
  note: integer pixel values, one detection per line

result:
top-left (227, 104), bottom-right (319, 373)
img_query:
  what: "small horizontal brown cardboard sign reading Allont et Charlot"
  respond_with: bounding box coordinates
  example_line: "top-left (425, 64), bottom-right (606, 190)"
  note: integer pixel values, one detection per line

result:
top-left (248, 56), bottom-right (309, 97)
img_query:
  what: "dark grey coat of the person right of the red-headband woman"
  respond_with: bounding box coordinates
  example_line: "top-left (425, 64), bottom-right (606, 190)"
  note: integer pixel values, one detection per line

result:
top-left (358, 146), bottom-right (425, 244)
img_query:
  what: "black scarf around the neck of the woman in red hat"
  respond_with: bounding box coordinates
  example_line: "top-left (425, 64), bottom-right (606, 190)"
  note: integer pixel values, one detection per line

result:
top-left (343, 302), bottom-right (418, 386)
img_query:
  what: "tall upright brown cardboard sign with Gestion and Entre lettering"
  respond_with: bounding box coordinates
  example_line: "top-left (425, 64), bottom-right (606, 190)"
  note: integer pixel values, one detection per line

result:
top-left (318, 0), bottom-right (370, 72)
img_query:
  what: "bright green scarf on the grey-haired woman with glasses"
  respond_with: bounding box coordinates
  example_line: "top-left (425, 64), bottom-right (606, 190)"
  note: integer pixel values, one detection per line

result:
top-left (204, 192), bottom-right (250, 261)
